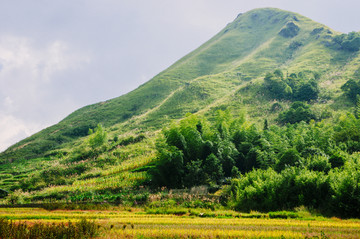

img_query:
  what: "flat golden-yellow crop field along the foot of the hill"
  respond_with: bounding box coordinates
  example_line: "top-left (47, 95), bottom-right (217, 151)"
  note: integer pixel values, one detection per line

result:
top-left (0, 207), bottom-right (360, 238)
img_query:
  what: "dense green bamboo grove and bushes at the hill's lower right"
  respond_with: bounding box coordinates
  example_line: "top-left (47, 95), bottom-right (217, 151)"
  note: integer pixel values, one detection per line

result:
top-left (152, 111), bottom-right (360, 217)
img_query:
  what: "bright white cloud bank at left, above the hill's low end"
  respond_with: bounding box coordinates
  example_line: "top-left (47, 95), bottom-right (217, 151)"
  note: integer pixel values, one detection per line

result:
top-left (0, 35), bottom-right (90, 151)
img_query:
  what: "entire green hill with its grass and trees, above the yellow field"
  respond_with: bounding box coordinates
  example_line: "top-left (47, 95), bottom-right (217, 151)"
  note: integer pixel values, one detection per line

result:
top-left (0, 8), bottom-right (360, 221)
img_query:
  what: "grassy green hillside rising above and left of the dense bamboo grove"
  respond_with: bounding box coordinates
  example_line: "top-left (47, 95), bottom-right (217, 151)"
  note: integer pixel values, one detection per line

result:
top-left (0, 8), bottom-right (360, 213)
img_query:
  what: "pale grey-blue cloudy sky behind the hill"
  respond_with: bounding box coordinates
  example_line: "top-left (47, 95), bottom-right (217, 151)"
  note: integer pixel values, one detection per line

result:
top-left (0, 0), bottom-right (360, 152)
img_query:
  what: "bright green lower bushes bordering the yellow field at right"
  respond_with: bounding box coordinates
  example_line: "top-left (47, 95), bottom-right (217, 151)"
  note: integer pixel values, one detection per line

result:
top-left (226, 160), bottom-right (360, 217)
